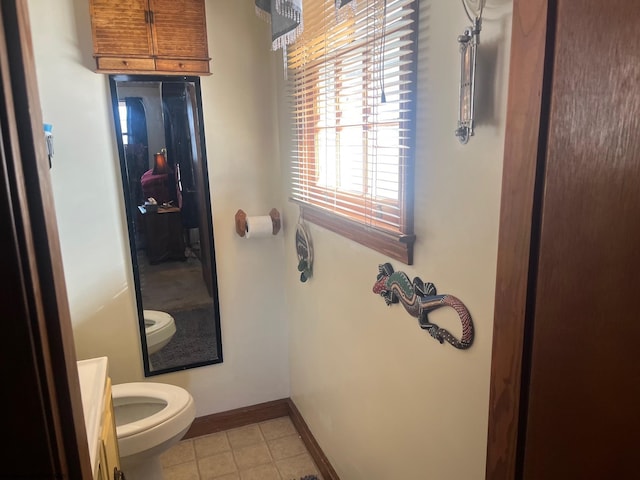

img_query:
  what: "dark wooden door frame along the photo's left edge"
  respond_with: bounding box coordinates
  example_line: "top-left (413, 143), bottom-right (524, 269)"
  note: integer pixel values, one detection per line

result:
top-left (0, 0), bottom-right (93, 479)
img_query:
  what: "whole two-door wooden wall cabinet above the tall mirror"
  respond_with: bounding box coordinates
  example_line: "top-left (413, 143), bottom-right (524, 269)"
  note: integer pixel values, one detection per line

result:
top-left (90, 0), bottom-right (211, 75)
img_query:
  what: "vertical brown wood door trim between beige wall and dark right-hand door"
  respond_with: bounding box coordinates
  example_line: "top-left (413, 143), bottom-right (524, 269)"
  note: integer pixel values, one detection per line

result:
top-left (486, 0), bottom-right (548, 480)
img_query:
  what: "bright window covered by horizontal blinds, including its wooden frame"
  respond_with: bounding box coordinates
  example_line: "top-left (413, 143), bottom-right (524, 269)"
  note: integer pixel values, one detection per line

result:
top-left (288, 0), bottom-right (417, 264)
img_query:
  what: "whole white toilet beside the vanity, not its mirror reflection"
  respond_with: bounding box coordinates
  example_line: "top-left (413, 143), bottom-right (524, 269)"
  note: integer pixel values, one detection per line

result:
top-left (111, 382), bottom-right (196, 480)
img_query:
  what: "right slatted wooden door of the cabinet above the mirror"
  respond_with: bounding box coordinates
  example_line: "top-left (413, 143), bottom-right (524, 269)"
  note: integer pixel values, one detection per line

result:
top-left (149, 0), bottom-right (209, 60)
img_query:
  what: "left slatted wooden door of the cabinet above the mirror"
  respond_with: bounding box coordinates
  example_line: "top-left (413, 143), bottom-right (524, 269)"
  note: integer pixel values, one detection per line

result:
top-left (91, 0), bottom-right (154, 56)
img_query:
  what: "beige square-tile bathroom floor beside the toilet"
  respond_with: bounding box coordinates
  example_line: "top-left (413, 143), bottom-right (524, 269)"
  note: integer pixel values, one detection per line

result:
top-left (160, 417), bottom-right (322, 480)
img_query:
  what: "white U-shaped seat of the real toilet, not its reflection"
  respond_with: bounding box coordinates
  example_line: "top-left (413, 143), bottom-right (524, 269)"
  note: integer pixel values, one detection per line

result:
top-left (111, 382), bottom-right (193, 438)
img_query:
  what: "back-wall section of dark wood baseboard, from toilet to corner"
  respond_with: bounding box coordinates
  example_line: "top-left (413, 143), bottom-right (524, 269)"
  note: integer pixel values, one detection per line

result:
top-left (183, 398), bottom-right (289, 439)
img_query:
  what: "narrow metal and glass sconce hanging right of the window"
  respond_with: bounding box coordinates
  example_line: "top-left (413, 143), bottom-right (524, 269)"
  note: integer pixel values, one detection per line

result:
top-left (456, 17), bottom-right (482, 144)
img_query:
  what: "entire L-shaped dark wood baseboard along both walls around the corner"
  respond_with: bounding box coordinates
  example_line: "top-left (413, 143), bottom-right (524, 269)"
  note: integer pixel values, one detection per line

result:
top-left (183, 398), bottom-right (340, 480)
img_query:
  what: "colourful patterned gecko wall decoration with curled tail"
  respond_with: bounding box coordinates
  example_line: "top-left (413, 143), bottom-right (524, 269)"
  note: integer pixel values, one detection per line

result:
top-left (373, 263), bottom-right (474, 350)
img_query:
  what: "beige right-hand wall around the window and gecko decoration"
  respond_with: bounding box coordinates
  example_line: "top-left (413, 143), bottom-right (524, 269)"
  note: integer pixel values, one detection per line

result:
top-left (281, 0), bottom-right (511, 480)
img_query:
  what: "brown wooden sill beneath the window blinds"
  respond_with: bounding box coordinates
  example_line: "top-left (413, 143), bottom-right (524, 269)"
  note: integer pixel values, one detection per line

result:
top-left (300, 205), bottom-right (416, 265)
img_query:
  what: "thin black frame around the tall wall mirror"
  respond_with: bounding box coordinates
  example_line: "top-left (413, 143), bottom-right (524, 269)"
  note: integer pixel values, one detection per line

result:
top-left (109, 74), bottom-right (223, 377)
